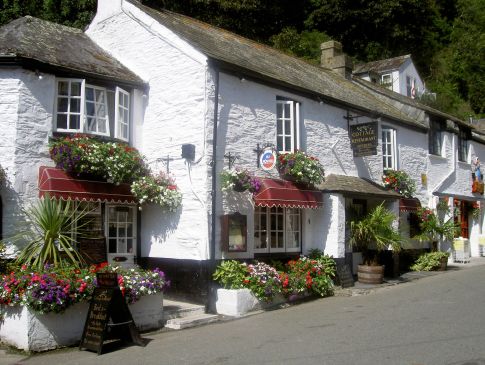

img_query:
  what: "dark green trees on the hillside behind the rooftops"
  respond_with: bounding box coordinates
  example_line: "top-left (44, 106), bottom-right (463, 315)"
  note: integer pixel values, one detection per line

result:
top-left (0, 0), bottom-right (485, 118)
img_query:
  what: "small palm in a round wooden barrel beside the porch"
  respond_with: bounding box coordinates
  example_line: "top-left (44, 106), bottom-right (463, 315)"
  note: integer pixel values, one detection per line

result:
top-left (350, 203), bottom-right (402, 284)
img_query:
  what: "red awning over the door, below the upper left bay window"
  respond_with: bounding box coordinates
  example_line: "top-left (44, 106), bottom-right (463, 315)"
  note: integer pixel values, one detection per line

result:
top-left (39, 166), bottom-right (137, 203)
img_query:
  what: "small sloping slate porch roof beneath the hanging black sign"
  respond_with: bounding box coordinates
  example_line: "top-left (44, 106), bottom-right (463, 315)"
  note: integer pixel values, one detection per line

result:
top-left (317, 174), bottom-right (402, 199)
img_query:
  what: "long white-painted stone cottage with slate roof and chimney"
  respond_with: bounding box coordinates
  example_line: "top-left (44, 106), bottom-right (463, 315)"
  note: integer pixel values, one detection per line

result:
top-left (0, 0), bottom-right (485, 302)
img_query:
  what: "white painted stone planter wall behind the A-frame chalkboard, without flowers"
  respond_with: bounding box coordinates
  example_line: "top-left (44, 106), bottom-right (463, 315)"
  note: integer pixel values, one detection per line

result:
top-left (0, 293), bottom-right (163, 352)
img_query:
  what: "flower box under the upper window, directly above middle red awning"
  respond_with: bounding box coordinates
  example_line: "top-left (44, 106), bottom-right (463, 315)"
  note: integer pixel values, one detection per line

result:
top-left (276, 151), bottom-right (325, 186)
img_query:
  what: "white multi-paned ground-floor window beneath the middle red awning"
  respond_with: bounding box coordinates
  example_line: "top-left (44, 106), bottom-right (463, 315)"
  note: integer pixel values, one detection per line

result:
top-left (253, 207), bottom-right (303, 253)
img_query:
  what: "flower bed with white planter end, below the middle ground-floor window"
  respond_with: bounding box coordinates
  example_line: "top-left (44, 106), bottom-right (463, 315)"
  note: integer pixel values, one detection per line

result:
top-left (214, 255), bottom-right (335, 316)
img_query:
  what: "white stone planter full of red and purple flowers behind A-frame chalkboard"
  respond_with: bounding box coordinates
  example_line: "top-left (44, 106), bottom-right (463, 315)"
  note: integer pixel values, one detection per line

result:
top-left (0, 265), bottom-right (169, 351)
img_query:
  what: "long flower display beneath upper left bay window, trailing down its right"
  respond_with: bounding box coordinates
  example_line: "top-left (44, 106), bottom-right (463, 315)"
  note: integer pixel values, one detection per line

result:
top-left (49, 134), bottom-right (182, 211)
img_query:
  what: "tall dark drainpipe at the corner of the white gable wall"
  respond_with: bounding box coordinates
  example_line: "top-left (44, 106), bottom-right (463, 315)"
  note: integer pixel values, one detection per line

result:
top-left (206, 67), bottom-right (219, 312)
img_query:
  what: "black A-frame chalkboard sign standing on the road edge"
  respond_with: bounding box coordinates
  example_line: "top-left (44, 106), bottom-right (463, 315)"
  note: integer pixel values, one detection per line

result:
top-left (79, 273), bottom-right (144, 355)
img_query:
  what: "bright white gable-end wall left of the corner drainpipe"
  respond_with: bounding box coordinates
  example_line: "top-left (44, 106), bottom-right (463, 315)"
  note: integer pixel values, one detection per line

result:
top-left (87, 1), bottom-right (212, 260)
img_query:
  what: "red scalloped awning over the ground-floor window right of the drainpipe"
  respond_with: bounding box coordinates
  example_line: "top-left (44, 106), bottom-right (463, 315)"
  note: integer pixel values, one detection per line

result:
top-left (254, 179), bottom-right (323, 209)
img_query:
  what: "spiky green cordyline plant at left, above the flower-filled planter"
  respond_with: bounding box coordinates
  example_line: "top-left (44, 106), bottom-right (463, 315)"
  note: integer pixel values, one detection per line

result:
top-left (9, 196), bottom-right (89, 270)
